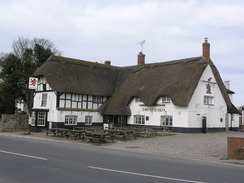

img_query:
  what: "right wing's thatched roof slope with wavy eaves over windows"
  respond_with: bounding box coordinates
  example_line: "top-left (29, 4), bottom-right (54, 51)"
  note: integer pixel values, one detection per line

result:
top-left (101, 57), bottom-right (207, 114)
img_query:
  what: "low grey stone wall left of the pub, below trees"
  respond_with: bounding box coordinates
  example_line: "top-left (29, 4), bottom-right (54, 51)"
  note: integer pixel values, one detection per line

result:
top-left (0, 114), bottom-right (29, 132)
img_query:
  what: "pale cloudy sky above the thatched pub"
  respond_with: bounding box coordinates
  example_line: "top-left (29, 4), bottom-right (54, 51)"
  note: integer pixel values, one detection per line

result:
top-left (0, 0), bottom-right (244, 107)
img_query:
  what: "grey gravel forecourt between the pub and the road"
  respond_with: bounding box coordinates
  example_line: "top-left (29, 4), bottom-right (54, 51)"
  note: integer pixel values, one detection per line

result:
top-left (3, 132), bottom-right (244, 165)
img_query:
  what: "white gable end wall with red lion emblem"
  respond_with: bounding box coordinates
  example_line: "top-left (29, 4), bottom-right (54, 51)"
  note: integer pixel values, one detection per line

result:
top-left (188, 66), bottom-right (231, 128)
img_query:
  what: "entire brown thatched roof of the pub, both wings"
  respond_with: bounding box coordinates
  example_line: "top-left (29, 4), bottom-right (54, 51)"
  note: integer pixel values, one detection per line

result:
top-left (34, 56), bottom-right (238, 115)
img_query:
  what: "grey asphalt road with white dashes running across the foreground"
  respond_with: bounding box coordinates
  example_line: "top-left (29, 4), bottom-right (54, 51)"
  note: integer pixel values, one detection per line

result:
top-left (0, 134), bottom-right (244, 183)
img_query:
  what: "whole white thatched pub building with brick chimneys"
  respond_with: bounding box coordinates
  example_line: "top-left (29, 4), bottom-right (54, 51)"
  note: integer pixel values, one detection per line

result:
top-left (29, 40), bottom-right (239, 132)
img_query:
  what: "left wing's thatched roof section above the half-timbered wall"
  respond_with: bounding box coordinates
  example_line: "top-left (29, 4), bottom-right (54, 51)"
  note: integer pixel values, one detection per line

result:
top-left (33, 56), bottom-right (118, 96)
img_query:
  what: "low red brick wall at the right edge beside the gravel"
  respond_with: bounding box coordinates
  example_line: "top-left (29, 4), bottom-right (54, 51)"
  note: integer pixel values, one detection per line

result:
top-left (228, 137), bottom-right (244, 159)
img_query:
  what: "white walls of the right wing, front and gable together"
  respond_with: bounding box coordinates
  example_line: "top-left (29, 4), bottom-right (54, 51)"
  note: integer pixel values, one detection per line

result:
top-left (127, 66), bottom-right (239, 128)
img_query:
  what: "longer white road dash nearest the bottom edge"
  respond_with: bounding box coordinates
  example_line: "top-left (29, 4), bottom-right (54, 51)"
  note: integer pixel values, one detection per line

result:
top-left (88, 166), bottom-right (205, 183)
